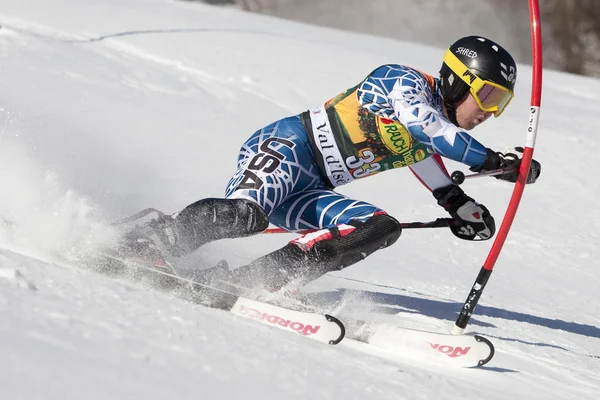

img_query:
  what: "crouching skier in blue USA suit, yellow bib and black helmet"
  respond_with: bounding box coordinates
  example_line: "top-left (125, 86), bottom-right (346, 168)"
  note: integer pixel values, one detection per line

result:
top-left (117, 36), bottom-right (541, 291)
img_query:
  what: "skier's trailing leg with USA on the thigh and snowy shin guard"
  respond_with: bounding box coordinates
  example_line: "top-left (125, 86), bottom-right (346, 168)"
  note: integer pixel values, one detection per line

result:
top-left (120, 117), bottom-right (323, 256)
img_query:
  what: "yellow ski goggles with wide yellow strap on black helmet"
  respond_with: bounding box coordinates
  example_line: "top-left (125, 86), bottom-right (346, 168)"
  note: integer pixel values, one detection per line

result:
top-left (444, 50), bottom-right (514, 118)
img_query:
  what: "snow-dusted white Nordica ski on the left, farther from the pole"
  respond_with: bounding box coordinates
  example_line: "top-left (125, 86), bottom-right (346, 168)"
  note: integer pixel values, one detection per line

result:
top-left (86, 253), bottom-right (346, 345)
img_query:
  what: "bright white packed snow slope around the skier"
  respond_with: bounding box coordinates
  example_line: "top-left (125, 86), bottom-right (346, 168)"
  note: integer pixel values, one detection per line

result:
top-left (0, 0), bottom-right (600, 400)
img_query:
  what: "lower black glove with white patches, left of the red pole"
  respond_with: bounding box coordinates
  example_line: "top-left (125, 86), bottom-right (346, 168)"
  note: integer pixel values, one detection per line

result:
top-left (433, 185), bottom-right (496, 240)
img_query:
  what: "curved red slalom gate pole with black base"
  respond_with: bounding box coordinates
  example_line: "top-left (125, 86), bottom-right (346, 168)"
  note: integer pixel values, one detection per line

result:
top-left (452, 0), bottom-right (542, 335)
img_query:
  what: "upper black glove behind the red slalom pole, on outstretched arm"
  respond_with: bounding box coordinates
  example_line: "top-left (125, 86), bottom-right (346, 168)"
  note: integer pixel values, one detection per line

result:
top-left (471, 147), bottom-right (542, 183)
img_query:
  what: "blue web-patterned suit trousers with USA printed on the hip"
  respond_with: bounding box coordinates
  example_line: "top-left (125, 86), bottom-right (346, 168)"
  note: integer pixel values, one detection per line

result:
top-left (226, 116), bottom-right (382, 231)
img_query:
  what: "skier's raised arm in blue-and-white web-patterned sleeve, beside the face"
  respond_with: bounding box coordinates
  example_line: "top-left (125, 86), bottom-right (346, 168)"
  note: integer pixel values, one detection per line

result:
top-left (359, 65), bottom-right (486, 167)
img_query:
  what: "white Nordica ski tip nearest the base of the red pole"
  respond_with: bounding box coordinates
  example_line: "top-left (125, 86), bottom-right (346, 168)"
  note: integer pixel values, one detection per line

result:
top-left (346, 321), bottom-right (495, 367)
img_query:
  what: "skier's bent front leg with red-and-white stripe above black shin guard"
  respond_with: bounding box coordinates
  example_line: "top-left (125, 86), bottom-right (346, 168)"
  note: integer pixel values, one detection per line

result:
top-left (232, 190), bottom-right (401, 290)
